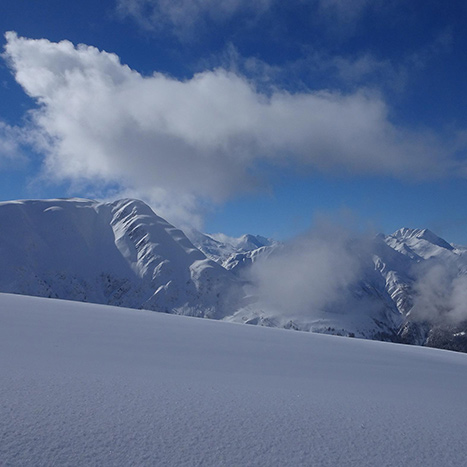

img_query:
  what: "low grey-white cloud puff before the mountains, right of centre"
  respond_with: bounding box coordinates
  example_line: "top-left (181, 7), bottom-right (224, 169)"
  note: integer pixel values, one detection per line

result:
top-left (248, 225), bottom-right (363, 318)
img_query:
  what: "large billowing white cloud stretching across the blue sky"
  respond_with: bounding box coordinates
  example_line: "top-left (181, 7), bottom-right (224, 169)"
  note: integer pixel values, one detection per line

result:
top-left (5, 33), bottom-right (458, 225)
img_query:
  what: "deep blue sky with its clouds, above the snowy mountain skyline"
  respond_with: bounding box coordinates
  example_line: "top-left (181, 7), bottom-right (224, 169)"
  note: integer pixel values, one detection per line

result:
top-left (0, 0), bottom-right (467, 244)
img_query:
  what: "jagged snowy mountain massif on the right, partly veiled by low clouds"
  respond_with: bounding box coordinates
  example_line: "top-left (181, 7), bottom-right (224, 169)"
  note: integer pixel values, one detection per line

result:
top-left (229, 228), bottom-right (467, 351)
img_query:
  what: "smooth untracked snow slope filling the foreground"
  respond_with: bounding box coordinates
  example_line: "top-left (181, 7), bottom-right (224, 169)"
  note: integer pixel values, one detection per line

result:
top-left (0, 294), bottom-right (467, 467)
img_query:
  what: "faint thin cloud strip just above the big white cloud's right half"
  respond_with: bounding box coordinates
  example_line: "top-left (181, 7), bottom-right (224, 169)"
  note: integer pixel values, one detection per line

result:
top-left (212, 30), bottom-right (452, 96)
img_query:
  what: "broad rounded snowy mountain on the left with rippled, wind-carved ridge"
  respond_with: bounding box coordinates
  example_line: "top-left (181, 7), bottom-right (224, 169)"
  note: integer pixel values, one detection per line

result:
top-left (0, 199), bottom-right (235, 318)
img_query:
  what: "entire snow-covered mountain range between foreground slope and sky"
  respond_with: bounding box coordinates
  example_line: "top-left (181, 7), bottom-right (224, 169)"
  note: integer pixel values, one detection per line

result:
top-left (0, 199), bottom-right (467, 351)
